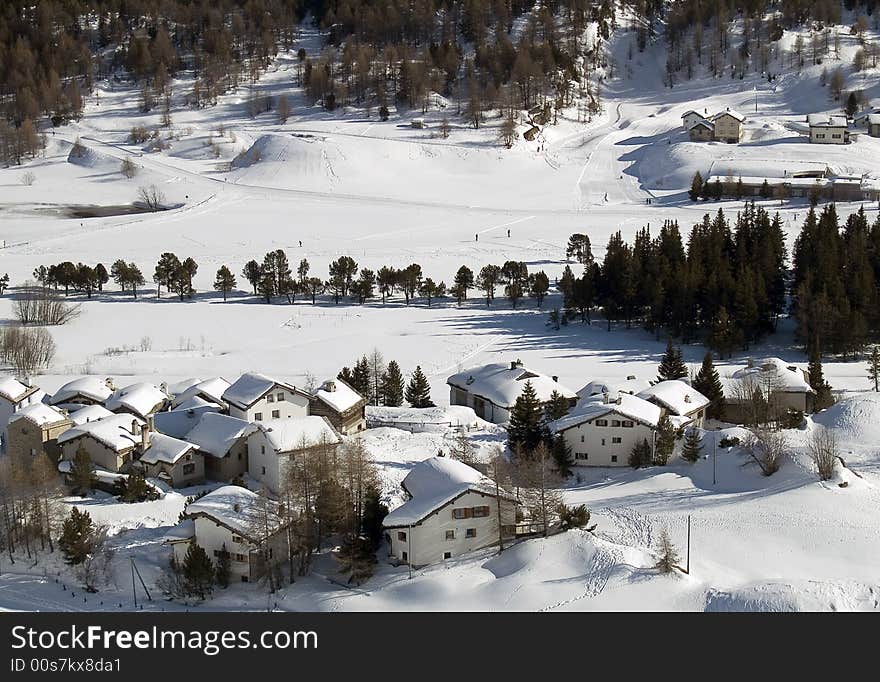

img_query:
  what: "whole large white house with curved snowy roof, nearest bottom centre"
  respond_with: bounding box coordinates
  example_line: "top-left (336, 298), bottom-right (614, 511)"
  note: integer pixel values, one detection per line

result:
top-left (383, 457), bottom-right (517, 566)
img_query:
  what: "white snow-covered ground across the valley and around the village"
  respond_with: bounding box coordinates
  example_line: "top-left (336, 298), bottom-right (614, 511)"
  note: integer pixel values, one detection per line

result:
top-left (0, 18), bottom-right (880, 610)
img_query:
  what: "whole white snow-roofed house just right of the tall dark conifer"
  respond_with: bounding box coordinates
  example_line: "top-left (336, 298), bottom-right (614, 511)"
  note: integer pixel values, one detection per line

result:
top-left (549, 393), bottom-right (662, 466)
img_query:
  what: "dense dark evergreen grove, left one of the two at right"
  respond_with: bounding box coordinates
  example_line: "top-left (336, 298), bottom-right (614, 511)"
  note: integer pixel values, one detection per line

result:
top-left (551, 202), bottom-right (787, 357)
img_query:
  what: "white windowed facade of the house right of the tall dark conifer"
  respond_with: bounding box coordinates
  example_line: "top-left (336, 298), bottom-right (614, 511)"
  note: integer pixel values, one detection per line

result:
top-left (561, 413), bottom-right (654, 466)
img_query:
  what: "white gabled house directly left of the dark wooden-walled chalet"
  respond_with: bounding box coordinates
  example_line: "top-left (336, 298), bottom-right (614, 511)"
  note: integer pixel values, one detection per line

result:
top-left (221, 372), bottom-right (309, 422)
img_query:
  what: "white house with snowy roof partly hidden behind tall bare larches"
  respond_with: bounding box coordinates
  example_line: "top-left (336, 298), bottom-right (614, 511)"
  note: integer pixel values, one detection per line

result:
top-left (247, 416), bottom-right (342, 494)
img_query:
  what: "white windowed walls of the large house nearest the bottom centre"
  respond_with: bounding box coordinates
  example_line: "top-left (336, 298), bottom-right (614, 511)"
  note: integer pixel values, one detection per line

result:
top-left (385, 490), bottom-right (516, 566)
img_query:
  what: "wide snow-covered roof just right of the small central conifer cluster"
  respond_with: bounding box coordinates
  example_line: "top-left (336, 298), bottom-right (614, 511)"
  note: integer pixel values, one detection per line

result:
top-left (446, 361), bottom-right (577, 408)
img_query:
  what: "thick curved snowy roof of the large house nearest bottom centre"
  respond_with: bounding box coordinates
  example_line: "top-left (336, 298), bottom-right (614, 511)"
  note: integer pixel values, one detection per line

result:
top-left (382, 457), bottom-right (515, 528)
